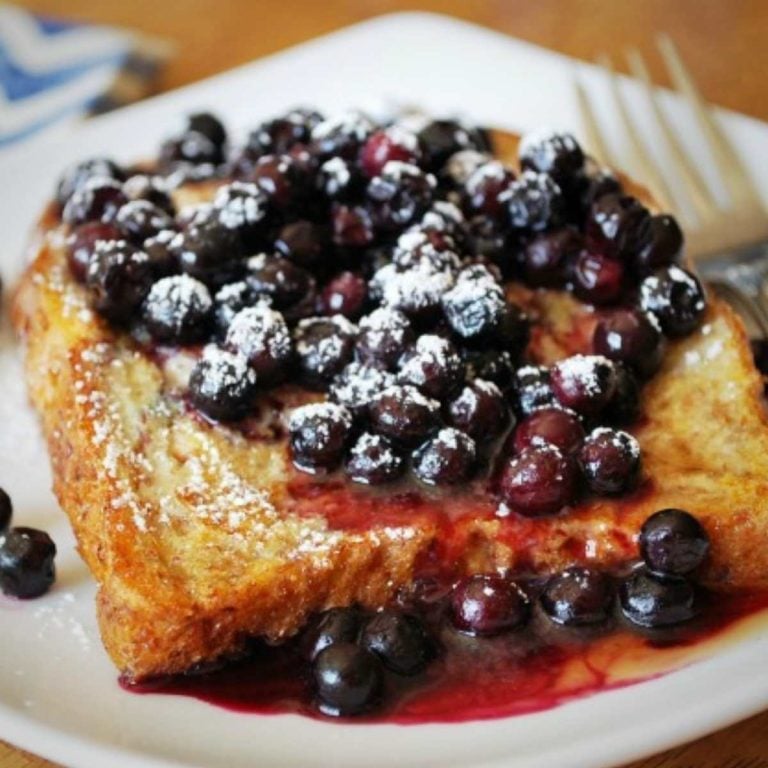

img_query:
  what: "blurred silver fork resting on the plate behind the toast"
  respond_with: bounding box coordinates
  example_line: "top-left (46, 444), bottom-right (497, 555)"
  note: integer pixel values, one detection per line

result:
top-left (575, 35), bottom-right (768, 337)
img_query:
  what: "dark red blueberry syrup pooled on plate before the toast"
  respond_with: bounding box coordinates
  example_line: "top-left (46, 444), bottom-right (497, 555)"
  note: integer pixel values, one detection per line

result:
top-left (121, 594), bottom-right (768, 725)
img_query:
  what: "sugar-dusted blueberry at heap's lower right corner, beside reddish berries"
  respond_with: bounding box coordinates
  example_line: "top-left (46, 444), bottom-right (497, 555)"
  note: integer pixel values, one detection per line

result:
top-left (579, 427), bottom-right (640, 496)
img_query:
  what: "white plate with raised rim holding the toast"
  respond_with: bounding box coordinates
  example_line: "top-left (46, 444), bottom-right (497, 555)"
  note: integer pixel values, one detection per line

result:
top-left (0, 14), bottom-right (768, 768)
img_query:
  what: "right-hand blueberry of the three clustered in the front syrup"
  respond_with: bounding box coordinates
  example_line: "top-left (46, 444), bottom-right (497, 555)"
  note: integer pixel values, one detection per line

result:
top-left (360, 610), bottom-right (434, 675)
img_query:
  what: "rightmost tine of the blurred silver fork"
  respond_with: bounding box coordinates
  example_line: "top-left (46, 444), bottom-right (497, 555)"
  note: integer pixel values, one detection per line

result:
top-left (657, 34), bottom-right (763, 209)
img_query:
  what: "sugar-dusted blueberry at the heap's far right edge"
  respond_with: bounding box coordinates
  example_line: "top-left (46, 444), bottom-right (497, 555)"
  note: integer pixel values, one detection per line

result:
top-left (640, 266), bottom-right (707, 336)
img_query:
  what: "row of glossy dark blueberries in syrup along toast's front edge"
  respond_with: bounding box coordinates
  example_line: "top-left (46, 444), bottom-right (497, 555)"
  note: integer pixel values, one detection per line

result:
top-left (301, 509), bottom-right (709, 716)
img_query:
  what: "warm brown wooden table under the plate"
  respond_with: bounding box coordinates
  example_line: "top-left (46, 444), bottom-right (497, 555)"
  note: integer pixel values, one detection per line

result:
top-left (0, 0), bottom-right (768, 768)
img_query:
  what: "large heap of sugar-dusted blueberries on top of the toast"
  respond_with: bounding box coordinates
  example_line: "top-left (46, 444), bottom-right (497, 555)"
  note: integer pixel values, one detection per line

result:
top-left (57, 103), bottom-right (706, 514)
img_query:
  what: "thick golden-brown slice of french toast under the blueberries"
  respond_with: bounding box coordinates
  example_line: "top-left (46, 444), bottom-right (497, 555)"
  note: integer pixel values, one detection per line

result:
top-left (12, 129), bottom-right (768, 680)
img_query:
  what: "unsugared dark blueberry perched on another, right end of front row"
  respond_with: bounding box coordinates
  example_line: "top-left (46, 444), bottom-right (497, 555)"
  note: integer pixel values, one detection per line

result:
top-left (640, 509), bottom-right (710, 576)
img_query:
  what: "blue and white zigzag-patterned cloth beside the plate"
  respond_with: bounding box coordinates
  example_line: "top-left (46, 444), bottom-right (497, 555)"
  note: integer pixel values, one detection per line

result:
top-left (0, 4), bottom-right (169, 152)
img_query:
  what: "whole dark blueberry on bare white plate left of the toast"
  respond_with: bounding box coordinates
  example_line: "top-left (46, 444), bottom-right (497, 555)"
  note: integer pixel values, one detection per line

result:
top-left (0, 528), bottom-right (56, 600)
